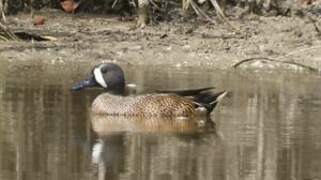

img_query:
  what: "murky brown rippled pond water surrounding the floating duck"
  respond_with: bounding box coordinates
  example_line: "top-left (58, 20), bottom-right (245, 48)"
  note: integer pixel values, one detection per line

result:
top-left (0, 61), bottom-right (321, 180)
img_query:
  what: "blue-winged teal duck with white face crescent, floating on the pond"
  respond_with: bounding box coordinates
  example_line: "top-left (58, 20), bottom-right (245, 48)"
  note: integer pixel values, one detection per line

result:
top-left (72, 63), bottom-right (227, 118)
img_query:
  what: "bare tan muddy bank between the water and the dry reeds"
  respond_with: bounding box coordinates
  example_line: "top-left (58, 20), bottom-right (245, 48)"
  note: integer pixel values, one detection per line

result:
top-left (0, 10), bottom-right (321, 69)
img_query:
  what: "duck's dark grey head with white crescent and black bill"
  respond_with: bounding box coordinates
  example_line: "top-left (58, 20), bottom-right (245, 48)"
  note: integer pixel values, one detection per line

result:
top-left (71, 63), bottom-right (125, 94)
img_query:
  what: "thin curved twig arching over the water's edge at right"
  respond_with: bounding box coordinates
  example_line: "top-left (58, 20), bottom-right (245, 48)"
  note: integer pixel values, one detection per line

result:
top-left (233, 57), bottom-right (319, 72)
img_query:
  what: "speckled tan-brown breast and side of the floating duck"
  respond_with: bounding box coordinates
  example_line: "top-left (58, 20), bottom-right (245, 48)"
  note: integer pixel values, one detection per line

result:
top-left (92, 93), bottom-right (199, 117)
